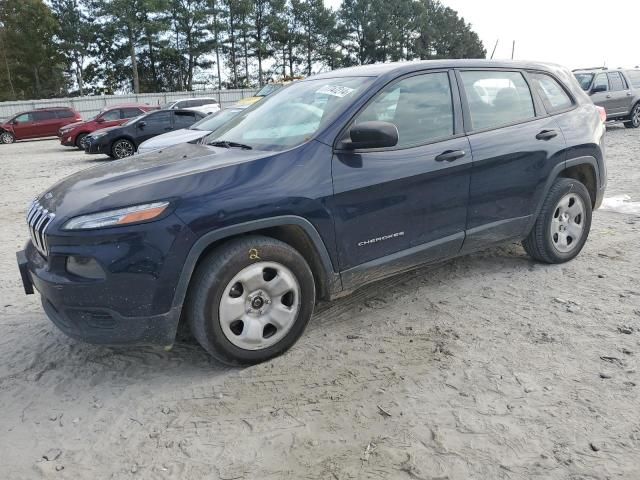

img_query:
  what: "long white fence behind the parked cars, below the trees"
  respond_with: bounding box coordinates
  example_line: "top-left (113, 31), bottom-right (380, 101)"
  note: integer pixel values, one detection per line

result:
top-left (0, 89), bottom-right (256, 121)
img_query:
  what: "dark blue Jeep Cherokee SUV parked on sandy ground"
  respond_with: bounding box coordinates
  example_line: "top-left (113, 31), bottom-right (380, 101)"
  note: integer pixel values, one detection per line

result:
top-left (18, 60), bottom-right (606, 364)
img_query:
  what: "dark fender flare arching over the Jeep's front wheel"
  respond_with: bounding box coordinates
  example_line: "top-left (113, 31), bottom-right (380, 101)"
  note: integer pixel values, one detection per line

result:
top-left (172, 215), bottom-right (342, 308)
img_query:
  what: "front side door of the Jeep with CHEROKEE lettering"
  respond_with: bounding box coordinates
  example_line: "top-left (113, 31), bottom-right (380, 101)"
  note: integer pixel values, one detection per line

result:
top-left (331, 71), bottom-right (471, 282)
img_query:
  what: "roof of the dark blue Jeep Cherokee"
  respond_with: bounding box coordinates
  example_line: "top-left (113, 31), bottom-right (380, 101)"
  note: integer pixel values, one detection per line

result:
top-left (312, 59), bottom-right (564, 82)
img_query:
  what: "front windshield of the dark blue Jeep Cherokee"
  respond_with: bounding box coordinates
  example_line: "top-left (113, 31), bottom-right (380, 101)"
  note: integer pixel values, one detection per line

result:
top-left (207, 77), bottom-right (373, 151)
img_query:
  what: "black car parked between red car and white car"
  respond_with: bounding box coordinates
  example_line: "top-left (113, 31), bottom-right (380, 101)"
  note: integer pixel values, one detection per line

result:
top-left (84, 110), bottom-right (205, 158)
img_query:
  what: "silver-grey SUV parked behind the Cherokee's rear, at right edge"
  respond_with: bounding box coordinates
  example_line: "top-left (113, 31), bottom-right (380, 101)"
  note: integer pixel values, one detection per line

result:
top-left (574, 68), bottom-right (640, 128)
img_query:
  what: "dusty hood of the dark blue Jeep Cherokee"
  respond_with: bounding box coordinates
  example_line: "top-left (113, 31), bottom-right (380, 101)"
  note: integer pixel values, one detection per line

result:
top-left (38, 143), bottom-right (272, 223)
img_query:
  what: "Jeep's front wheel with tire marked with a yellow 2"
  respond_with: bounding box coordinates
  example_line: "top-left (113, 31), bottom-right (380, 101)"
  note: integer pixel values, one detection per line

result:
top-left (186, 236), bottom-right (316, 365)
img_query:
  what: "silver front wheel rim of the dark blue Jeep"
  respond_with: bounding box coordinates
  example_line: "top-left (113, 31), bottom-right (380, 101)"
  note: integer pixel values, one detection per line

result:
top-left (218, 262), bottom-right (300, 350)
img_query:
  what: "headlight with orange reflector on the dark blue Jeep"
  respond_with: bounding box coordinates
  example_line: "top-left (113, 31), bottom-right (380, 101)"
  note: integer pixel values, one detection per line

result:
top-left (63, 202), bottom-right (169, 230)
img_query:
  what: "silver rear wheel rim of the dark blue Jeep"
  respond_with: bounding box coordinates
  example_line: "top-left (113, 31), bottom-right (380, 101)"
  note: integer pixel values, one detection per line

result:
top-left (550, 193), bottom-right (585, 253)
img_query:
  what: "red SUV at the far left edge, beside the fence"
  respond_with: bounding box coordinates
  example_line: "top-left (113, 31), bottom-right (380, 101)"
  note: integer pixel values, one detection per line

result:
top-left (0, 107), bottom-right (82, 143)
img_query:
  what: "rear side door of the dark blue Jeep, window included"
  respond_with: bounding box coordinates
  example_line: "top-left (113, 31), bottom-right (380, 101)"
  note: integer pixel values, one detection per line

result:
top-left (457, 69), bottom-right (573, 252)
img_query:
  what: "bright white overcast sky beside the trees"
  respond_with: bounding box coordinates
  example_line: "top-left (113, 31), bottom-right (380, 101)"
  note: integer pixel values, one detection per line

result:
top-left (325, 0), bottom-right (640, 68)
